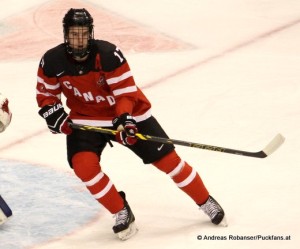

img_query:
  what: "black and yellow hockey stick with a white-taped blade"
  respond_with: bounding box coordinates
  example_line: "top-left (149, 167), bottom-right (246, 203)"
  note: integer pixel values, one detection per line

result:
top-left (70, 123), bottom-right (285, 158)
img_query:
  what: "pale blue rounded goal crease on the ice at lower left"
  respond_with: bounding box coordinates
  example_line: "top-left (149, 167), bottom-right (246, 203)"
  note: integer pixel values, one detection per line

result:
top-left (0, 160), bottom-right (101, 249)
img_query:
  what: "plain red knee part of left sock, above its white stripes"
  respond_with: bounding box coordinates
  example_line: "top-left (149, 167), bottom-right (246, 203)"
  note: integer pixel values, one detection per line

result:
top-left (72, 151), bottom-right (101, 182)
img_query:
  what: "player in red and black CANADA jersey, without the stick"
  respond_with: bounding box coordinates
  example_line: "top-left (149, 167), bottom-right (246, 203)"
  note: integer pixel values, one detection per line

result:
top-left (36, 9), bottom-right (225, 240)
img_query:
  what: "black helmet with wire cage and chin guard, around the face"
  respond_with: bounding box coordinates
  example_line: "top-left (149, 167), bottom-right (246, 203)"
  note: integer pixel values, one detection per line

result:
top-left (63, 9), bottom-right (94, 58)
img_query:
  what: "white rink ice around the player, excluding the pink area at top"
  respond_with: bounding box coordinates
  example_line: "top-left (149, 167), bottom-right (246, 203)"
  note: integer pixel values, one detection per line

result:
top-left (0, 0), bottom-right (300, 249)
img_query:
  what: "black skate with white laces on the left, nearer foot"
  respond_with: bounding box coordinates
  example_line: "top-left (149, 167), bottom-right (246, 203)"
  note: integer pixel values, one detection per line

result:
top-left (113, 191), bottom-right (138, 240)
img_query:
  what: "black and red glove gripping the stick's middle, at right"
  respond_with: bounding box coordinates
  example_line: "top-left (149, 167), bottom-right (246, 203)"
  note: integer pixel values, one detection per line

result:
top-left (112, 113), bottom-right (138, 145)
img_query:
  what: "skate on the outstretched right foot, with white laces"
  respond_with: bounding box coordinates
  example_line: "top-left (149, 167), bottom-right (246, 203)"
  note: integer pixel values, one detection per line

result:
top-left (199, 196), bottom-right (227, 227)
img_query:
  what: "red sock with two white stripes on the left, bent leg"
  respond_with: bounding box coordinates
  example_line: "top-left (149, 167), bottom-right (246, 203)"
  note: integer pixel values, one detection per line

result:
top-left (72, 152), bottom-right (124, 214)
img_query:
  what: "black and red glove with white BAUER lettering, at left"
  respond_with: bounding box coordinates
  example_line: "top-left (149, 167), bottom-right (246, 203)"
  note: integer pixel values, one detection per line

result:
top-left (39, 103), bottom-right (72, 135)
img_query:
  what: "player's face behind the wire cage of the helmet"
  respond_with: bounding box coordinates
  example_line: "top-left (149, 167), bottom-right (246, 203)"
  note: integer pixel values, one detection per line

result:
top-left (68, 26), bottom-right (90, 51)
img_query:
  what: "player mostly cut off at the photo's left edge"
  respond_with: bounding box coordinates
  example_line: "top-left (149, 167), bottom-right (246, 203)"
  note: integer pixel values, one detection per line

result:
top-left (0, 93), bottom-right (12, 225)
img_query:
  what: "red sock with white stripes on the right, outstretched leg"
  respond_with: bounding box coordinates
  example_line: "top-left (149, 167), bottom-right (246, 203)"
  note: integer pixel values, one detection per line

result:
top-left (153, 151), bottom-right (209, 204)
